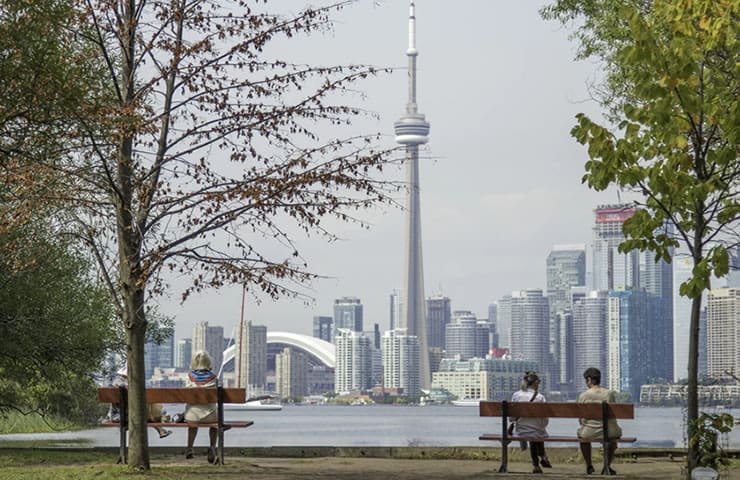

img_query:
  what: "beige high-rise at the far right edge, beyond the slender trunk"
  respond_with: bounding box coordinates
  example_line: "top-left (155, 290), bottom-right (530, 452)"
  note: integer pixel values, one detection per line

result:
top-left (707, 288), bottom-right (740, 378)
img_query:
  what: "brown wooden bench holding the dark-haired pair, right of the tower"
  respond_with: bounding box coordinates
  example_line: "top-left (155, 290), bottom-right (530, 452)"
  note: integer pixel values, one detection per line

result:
top-left (478, 401), bottom-right (637, 475)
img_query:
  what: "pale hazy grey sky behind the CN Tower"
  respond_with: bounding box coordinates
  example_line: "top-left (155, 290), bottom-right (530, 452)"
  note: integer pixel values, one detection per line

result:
top-left (159, 0), bottom-right (617, 338)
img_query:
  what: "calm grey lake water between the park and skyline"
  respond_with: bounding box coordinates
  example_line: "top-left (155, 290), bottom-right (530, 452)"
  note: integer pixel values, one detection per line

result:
top-left (0, 405), bottom-right (740, 448)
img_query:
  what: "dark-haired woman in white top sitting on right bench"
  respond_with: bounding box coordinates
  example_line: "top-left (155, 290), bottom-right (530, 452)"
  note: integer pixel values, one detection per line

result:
top-left (510, 372), bottom-right (552, 473)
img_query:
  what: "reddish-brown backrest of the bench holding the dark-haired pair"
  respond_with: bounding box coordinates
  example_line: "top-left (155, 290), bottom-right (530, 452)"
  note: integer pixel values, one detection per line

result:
top-left (480, 401), bottom-right (635, 419)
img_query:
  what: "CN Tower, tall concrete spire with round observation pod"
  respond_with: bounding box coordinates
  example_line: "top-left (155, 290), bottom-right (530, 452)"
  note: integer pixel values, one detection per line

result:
top-left (394, 0), bottom-right (431, 389)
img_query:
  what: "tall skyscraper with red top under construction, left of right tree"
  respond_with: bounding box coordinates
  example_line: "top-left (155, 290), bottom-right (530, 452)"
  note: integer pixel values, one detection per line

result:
top-left (592, 205), bottom-right (640, 290)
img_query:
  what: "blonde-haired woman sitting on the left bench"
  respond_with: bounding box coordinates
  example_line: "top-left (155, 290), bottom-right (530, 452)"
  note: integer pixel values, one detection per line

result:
top-left (185, 350), bottom-right (218, 463)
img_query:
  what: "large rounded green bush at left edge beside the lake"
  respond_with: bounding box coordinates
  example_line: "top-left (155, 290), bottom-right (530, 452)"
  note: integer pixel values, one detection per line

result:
top-left (0, 222), bottom-right (114, 421)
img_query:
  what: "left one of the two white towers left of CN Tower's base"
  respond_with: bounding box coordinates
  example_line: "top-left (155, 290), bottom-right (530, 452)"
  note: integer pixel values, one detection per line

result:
top-left (334, 328), bottom-right (372, 394)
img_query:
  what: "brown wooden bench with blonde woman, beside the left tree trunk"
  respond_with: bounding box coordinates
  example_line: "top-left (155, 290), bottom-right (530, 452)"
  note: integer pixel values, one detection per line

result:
top-left (98, 387), bottom-right (254, 465)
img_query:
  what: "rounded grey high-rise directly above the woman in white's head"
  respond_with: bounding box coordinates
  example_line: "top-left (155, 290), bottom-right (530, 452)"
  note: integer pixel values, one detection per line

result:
top-left (511, 289), bottom-right (552, 378)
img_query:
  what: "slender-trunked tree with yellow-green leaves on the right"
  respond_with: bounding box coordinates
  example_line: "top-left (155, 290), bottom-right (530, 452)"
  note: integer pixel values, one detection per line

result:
top-left (542, 0), bottom-right (740, 475)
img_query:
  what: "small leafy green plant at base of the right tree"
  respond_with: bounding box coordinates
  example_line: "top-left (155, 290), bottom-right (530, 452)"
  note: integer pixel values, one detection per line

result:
top-left (689, 413), bottom-right (735, 470)
